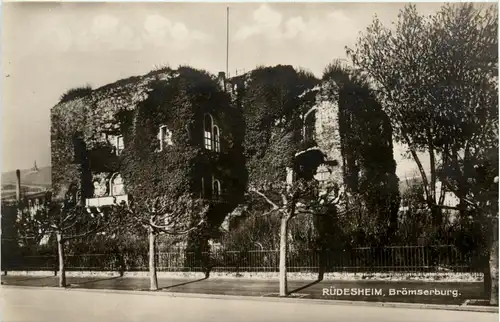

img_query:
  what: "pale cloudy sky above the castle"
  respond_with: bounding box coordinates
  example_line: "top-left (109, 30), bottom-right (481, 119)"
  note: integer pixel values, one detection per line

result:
top-left (1, 2), bottom-right (448, 177)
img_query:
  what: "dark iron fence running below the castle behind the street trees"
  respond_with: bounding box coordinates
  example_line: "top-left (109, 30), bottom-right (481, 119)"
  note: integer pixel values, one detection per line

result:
top-left (2, 245), bottom-right (482, 273)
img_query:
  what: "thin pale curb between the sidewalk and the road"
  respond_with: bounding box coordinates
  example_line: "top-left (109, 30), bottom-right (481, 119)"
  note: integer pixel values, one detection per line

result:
top-left (0, 284), bottom-right (499, 313)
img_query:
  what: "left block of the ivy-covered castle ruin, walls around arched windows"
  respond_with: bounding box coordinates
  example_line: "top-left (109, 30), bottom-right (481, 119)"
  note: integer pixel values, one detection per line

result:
top-left (51, 67), bottom-right (246, 231)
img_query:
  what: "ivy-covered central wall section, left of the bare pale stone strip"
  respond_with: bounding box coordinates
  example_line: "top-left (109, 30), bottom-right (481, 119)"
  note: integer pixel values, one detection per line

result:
top-left (231, 65), bottom-right (318, 185)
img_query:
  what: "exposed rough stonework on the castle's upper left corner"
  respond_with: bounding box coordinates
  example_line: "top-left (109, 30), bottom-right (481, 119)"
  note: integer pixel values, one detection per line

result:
top-left (51, 70), bottom-right (171, 195)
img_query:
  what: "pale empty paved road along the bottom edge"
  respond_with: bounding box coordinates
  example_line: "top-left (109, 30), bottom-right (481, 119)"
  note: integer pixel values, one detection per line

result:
top-left (0, 287), bottom-right (498, 322)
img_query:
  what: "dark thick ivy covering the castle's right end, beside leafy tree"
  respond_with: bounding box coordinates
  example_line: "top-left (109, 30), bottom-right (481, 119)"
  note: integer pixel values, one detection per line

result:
top-left (323, 64), bottom-right (400, 244)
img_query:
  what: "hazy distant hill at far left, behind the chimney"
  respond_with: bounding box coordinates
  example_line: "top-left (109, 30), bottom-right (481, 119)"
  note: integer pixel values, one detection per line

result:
top-left (2, 166), bottom-right (52, 190)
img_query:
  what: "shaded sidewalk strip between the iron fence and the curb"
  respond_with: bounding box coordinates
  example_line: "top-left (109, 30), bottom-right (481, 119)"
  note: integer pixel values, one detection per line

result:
top-left (1, 275), bottom-right (492, 305)
